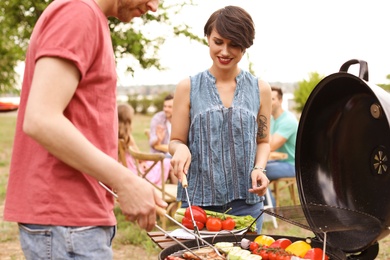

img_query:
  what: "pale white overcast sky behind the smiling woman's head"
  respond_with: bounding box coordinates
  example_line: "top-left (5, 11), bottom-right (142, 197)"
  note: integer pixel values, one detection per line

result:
top-left (118, 0), bottom-right (390, 85)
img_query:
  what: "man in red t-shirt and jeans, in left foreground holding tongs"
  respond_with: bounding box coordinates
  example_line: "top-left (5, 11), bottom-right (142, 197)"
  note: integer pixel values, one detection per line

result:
top-left (4, 0), bottom-right (167, 260)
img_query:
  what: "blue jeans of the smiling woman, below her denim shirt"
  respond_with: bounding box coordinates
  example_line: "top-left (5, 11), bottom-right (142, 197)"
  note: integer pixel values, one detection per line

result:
top-left (181, 200), bottom-right (264, 234)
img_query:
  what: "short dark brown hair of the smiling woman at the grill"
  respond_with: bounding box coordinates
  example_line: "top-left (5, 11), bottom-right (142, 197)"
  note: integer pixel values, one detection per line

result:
top-left (204, 5), bottom-right (255, 50)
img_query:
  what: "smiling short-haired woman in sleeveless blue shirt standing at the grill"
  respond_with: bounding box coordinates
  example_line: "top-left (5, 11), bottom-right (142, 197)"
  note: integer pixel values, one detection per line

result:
top-left (169, 6), bottom-right (271, 233)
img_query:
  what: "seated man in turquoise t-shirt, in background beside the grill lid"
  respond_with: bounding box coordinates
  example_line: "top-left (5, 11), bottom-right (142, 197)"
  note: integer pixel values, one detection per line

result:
top-left (266, 86), bottom-right (298, 205)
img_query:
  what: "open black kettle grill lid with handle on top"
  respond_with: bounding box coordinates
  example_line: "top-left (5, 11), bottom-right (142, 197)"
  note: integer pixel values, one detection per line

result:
top-left (295, 60), bottom-right (390, 253)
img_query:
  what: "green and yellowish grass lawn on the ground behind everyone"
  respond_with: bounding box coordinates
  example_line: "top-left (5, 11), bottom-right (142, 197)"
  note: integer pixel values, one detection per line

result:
top-left (0, 113), bottom-right (390, 260)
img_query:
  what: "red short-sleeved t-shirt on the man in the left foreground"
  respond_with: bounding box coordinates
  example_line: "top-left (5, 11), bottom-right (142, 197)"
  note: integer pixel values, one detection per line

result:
top-left (4, 0), bottom-right (118, 226)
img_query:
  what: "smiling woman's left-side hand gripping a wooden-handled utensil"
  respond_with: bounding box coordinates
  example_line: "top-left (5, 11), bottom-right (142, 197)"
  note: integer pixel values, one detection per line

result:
top-left (171, 142), bottom-right (191, 182)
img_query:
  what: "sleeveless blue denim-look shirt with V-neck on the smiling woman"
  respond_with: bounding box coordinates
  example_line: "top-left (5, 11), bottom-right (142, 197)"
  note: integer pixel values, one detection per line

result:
top-left (177, 70), bottom-right (261, 206)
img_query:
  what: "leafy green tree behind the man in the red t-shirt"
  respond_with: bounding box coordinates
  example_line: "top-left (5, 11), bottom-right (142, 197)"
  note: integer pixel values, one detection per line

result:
top-left (0, 0), bottom-right (206, 94)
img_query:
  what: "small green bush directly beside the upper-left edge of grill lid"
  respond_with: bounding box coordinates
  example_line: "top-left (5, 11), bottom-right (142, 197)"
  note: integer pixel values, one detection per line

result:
top-left (294, 72), bottom-right (324, 112)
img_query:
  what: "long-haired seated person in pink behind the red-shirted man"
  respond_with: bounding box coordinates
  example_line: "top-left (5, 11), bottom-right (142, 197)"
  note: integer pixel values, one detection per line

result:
top-left (118, 104), bottom-right (177, 187)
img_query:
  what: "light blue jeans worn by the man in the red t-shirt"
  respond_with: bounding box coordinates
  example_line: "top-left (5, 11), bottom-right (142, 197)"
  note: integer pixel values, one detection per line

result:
top-left (19, 224), bottom-right (116, 260)
